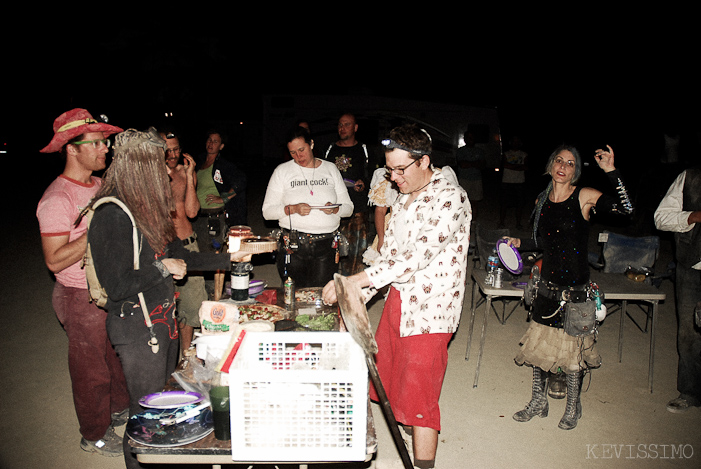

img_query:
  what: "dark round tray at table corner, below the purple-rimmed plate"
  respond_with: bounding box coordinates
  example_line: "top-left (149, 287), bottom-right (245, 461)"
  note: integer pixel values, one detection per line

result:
top-left (125, 406), bottom-right (214, 448)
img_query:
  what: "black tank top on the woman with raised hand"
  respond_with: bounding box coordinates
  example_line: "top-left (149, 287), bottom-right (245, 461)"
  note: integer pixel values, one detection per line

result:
top-left (538, 187), bottom-right (589, 287)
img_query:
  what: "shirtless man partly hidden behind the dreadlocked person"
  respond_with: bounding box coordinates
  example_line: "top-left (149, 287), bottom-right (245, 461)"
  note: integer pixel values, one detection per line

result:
top-left (161, 133), bottom-right (209, 351)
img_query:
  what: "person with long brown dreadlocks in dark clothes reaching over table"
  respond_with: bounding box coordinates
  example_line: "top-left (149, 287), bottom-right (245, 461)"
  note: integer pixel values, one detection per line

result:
top-left (83, 128), bottom-right (250, 468)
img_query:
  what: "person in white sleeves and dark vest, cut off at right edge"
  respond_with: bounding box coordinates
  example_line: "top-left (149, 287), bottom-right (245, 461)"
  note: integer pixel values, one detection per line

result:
top-left (655, 167), bottom-right (701, 413)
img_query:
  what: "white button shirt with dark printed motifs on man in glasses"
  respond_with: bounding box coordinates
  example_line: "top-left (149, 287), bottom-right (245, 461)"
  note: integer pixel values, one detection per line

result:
top-left (364, 170), bottom-right (472, 337)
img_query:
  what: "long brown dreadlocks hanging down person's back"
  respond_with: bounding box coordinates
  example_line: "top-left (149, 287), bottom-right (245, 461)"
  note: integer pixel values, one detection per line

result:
top-left (93, 127), bottom-right (176, 252)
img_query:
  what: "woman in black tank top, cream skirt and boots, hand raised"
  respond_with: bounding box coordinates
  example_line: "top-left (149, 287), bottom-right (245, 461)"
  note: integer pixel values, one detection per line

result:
top-left (508, 145), bottom-right (633, 430)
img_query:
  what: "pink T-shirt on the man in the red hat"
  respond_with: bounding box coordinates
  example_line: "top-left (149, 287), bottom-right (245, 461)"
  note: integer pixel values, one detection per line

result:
top-left (37, 175), bottom-right (102, 288)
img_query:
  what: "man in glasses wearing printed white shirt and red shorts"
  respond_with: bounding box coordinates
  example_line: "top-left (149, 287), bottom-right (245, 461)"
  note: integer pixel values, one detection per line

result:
top-left (323, 125), bottom-right (472, 468)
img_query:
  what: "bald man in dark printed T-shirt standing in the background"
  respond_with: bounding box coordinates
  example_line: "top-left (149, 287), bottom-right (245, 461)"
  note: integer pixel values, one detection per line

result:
top-left (323, 113), bottom-right (370, 275)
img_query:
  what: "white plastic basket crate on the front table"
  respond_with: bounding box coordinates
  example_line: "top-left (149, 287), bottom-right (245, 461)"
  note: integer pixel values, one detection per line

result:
top-left (229, 332), bottom-right (368, 462)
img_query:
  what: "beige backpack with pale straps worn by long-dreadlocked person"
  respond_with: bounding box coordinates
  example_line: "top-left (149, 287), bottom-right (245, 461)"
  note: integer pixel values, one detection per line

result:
top-left (81, 196), bottom-right (159, 353)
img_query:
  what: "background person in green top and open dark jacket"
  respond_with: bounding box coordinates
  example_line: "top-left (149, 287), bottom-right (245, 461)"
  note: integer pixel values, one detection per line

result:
top-left (194, 130), bottom-right (248, 251)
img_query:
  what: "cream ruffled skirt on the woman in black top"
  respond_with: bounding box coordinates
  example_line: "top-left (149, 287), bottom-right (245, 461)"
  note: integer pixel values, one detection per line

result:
top-left (514, 321), bottom-right (601, 373)
